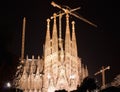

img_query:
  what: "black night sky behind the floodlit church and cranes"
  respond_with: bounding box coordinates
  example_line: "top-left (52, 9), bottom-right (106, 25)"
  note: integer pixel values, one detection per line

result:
top-left (0, 0), bottom-right (120, 87)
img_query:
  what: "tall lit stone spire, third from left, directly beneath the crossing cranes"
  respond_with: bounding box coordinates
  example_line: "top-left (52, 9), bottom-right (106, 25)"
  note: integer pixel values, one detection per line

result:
top-left (65, 14), bottom-right (71, 53)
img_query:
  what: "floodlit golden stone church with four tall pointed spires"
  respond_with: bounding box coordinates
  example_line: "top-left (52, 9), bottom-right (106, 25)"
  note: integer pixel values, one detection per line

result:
top-left (14, 14), bottom-right (88, 92)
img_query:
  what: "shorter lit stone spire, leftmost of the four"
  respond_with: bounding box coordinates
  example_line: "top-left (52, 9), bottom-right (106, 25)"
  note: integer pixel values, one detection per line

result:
top-left (44, 19), bottom-right (51, 57)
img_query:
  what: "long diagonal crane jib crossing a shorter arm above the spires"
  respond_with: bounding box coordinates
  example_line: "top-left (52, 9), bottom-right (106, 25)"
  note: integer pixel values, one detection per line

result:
top-left (51, 1), bottom-right (97, 27)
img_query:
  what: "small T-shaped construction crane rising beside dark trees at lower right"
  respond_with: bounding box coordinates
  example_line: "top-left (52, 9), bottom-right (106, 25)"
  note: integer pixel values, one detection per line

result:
top-left (94, 66), bottom-right (110, 88)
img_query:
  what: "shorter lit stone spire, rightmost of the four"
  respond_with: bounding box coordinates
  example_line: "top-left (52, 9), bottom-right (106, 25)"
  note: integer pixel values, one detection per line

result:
top-left (72, 21), bottom-right (77, 57)
